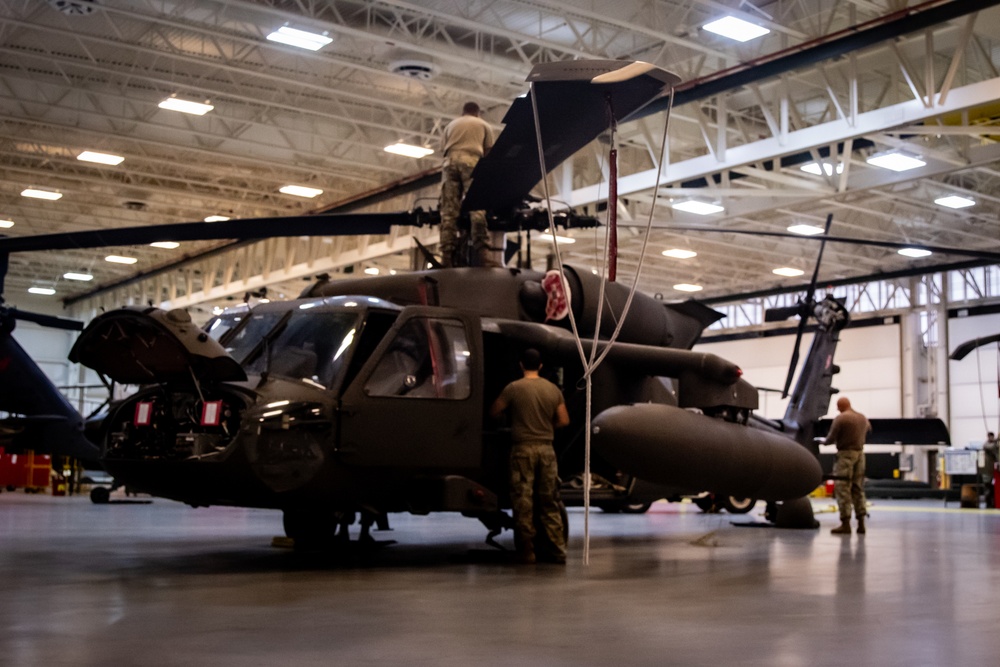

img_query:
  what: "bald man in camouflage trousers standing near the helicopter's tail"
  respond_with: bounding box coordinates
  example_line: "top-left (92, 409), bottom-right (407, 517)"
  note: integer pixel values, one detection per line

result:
top-left (826, 398), bottom-right (872, 535)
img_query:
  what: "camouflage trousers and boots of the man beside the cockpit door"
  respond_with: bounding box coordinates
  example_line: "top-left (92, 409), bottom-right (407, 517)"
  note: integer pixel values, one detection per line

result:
top-left (510, 442), bottom-right (566, 561)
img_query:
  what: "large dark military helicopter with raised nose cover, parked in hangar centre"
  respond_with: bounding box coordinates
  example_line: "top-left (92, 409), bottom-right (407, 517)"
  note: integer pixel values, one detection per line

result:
top-left (0, 61), bottom-right (846, 548)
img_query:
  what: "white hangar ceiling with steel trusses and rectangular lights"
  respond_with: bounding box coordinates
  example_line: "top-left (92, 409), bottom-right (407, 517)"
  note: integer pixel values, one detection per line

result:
top-left (0, 0), bottom-right (1000, 316)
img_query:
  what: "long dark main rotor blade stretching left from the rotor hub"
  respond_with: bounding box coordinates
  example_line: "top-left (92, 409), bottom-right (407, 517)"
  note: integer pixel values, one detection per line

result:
top-left (0, 211), bottom-right (421, 256)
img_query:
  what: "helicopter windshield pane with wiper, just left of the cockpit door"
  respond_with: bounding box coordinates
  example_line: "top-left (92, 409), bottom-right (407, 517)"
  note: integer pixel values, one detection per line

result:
top-left (244, 311), bottom-right (360, 389)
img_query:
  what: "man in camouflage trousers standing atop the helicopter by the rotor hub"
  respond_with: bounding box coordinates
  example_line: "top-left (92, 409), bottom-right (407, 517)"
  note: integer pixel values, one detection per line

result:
top-left (439, 102), bottom-right (498, 267)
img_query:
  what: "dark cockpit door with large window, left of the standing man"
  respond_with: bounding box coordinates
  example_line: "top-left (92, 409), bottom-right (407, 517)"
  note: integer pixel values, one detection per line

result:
top-left (338, 306), bottom-right (483, 474)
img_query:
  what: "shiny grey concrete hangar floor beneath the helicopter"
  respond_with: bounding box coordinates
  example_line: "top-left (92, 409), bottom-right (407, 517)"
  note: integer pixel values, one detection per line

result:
top-left (0, 493), bottom-right (1000, 666)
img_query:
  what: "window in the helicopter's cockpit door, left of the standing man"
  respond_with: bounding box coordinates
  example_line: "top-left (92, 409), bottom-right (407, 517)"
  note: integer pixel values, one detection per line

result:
top-left (365, 317), bottom-right (472, 400)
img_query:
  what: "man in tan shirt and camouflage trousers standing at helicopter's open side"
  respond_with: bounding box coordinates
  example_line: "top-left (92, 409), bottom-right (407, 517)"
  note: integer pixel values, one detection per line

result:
top-left (490, 349), bottom-right (569, 564)
